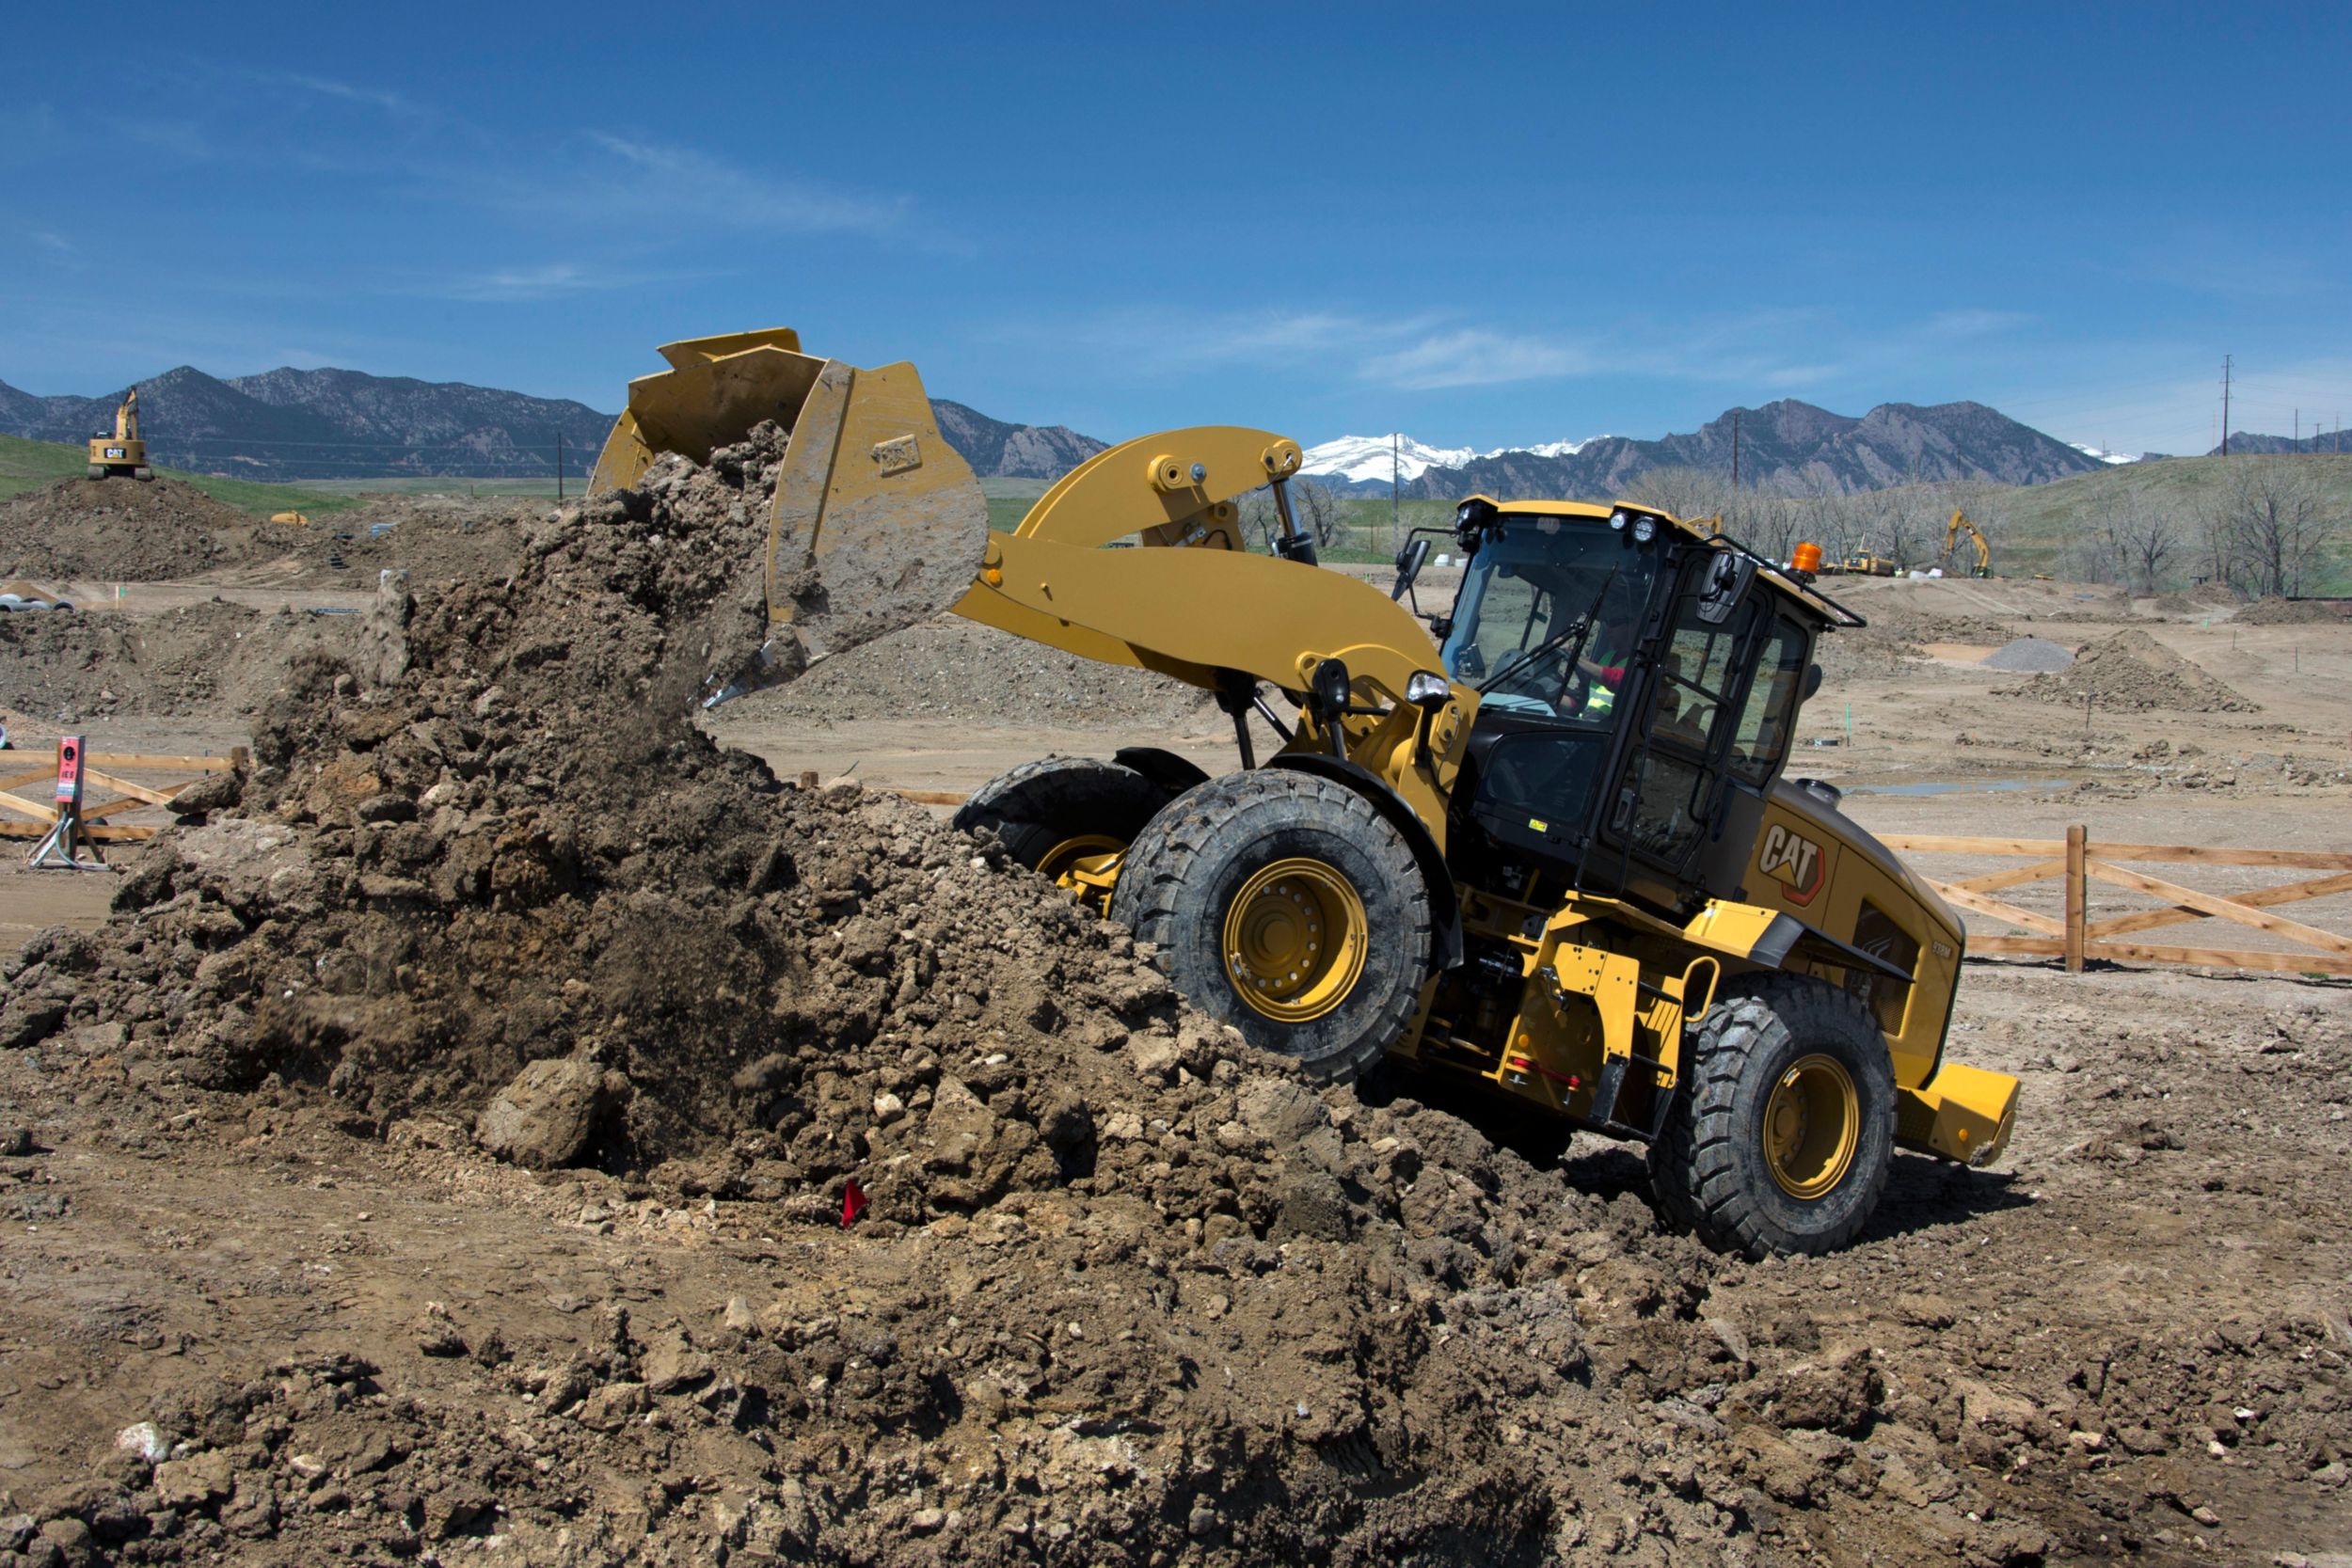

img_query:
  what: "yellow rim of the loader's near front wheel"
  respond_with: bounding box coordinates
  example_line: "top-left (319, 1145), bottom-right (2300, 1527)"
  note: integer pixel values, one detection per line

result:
top-left (1223, 858), bottom-right (1372, 1022)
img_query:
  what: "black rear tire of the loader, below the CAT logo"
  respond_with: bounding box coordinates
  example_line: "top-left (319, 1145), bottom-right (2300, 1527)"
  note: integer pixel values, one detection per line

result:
top-left (1649, 975), bottom-right (1896, 1258)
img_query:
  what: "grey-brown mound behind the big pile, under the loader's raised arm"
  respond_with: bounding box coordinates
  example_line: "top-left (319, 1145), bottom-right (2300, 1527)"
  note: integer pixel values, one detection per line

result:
top-left (724, 618), bottom-right (1223, 726)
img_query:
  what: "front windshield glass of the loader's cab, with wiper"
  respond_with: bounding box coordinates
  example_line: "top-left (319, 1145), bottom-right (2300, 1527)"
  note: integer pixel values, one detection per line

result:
top-left (1444, 517), bottom-right (1663, 721)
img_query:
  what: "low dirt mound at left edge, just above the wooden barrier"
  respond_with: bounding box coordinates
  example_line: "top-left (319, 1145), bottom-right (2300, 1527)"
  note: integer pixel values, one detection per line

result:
top-left (0, 599), bottom-right (353, 724)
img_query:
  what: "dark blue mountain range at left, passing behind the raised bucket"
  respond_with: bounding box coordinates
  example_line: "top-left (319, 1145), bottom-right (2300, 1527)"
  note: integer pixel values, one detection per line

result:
top-left (0, 364), bottom-right (1104, 482)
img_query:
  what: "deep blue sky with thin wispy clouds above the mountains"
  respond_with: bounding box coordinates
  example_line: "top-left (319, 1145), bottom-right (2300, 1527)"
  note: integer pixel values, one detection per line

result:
top-left (0, 5), bottom-right (2352, 451)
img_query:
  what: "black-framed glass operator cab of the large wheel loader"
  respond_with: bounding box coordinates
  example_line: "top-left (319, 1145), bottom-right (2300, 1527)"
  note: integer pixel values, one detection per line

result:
top-left (1439, 496), bottom-right (1837, 914)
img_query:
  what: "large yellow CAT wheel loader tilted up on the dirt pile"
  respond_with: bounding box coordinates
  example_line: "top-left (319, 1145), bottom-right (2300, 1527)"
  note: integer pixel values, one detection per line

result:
top-left (597, 331), bottom-right (2018, 1256)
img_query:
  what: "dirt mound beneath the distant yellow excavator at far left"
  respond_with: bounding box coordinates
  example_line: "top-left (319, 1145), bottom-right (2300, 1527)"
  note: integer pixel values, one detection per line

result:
top-left (0, 480), bottom-right (310, 583)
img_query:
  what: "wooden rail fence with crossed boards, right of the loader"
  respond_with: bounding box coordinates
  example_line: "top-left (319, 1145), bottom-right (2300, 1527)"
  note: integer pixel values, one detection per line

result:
top-left (1882, 828), bottom-right (2352, 975)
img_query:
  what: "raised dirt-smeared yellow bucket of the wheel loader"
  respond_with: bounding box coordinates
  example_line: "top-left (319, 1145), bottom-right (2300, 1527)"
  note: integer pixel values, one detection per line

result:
top-left (588, 326), bottom-right (988, 703)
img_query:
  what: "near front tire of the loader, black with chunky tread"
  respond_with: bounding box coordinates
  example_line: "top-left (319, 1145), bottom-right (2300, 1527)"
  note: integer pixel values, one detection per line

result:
top-left (1110, 768), bottom-right (1430, 1084)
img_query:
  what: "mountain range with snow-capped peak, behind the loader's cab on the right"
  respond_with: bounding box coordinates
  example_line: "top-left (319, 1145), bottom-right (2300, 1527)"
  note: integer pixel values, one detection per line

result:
top-left (1306, 397), bottom-right (2112, 499)
